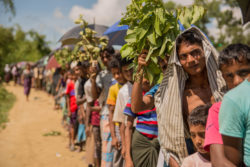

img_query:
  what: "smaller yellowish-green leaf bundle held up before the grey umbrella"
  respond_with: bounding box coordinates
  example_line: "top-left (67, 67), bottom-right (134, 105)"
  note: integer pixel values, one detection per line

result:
top-left (73, 15), bottom-right (108, 62)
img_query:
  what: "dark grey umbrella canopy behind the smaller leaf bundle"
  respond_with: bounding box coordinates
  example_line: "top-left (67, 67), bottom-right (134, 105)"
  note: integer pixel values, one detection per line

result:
top-left (59, 24), bottom-right (108, 46)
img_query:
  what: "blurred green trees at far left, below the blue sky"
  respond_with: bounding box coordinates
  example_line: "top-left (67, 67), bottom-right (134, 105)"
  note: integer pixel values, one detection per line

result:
top-left (0, 25), bottom-right (50, 75)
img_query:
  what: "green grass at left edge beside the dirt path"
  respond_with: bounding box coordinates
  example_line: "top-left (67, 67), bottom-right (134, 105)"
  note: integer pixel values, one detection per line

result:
top-left (0, 85), bottom-right (16, 130)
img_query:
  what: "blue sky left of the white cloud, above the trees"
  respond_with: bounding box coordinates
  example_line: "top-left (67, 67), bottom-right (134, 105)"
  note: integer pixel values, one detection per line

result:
top-left (0, 0), bottom-right (97, 49)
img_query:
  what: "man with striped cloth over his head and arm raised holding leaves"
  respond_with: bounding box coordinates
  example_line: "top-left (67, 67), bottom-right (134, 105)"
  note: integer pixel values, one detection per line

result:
top-left (132, 28), bottom-right (224, 166)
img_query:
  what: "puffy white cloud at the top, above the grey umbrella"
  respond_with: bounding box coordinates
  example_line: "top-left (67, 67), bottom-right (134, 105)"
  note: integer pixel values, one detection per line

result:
top-left (69, 0), bottom-right (130, 26)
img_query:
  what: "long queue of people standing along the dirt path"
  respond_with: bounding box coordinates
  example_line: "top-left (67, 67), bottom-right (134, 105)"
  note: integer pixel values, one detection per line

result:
top-left (3, 27), bottom-right (250, 167)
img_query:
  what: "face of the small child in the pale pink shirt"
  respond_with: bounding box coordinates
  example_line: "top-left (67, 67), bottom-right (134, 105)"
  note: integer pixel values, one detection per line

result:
top-left (189, 125), bottom-right (207, 154)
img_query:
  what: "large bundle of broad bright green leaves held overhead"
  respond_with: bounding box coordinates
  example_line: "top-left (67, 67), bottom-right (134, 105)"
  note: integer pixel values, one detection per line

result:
top-left (120, 0), bottom-right (205, 83)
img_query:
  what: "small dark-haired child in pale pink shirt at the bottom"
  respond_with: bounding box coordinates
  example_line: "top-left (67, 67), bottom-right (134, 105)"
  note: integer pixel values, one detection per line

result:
top-left (182, 104), bottom-right (212, 167)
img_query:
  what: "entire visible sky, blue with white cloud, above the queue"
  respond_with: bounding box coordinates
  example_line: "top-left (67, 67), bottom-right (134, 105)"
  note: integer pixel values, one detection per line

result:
top-left (0, 0), bottom-right (241, 49)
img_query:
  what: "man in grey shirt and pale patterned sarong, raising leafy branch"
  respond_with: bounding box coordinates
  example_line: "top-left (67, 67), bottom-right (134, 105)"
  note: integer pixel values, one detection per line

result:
top-left (90, 47), bottom-right (115, 166)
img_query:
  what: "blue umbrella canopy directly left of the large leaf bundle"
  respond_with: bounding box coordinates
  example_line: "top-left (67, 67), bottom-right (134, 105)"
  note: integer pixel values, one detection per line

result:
top-left (103, 21), bottom-right (128, 46)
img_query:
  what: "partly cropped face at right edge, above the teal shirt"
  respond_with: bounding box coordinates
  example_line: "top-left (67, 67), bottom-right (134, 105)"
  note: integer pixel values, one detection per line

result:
top-left (221, 60), bottom-right (250, 89)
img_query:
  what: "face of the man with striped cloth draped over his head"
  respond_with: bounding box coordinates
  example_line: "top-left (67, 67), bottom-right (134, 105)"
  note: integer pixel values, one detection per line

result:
top-left (178, 42), bottom-right (206, 75)
